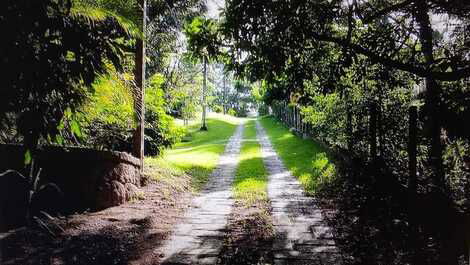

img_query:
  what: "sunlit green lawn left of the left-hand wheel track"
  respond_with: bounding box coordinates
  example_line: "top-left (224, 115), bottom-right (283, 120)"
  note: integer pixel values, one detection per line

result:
top-left (145, 114), bottom-right (240, 191)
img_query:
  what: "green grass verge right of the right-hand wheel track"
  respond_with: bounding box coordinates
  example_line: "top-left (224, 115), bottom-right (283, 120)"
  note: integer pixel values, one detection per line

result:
top-left (260, 117), bottom-right (335, 195)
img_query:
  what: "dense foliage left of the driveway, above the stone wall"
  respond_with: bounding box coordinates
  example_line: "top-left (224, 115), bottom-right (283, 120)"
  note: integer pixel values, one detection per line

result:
top-left (0, 0), bottom-right (204, 155)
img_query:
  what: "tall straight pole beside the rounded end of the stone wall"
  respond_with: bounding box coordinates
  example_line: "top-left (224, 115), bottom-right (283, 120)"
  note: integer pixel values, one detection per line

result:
top-left (132, 0), bottom-right (147, 170)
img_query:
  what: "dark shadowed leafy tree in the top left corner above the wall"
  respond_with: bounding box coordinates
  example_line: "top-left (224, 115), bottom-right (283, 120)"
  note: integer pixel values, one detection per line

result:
top-left (0, 0), bottom-right (129, 156)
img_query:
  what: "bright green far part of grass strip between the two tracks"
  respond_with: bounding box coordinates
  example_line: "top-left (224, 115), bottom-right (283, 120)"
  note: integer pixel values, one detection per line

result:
top-left (233, 120), bottom-right (268, 206)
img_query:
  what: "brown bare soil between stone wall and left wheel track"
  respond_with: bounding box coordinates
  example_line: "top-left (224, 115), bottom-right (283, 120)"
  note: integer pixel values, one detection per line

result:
top-left (0, 177), bottom-right (192, 265)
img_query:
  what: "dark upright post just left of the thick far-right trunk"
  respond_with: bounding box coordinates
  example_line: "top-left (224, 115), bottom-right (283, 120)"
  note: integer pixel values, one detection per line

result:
top-left (408, 106), bottom-right (418, 194)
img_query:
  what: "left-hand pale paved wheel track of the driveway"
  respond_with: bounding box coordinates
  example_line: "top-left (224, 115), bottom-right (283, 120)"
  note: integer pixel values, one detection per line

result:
top-left (161, 125), bottom-right (243, 264)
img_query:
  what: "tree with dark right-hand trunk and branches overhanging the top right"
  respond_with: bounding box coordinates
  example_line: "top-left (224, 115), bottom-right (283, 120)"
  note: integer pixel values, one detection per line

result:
top-left (222, 0), bottom-right (470, 188)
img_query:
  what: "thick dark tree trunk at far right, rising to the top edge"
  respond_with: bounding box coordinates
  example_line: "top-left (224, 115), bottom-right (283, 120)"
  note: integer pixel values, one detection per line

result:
top-left (415, 0), bottom-right (445, 189)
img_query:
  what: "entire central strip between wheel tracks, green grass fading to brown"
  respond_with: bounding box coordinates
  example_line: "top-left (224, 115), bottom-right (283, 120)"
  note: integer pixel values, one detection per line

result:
top-left (220, 120), bottom-right (275, 264)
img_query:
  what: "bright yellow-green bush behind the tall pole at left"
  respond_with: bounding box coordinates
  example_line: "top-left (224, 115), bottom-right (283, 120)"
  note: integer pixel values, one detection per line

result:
top-left (78, 69), bottom-right (186, 156)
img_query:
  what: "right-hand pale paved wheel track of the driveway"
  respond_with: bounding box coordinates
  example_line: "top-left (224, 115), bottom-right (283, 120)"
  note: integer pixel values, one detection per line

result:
top-left (256, 121), bottom-right (341, 265)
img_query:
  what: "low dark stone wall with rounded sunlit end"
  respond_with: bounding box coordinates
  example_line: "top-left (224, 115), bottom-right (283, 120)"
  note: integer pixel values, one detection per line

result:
top-left (0, 145), bottom-right (141, 230)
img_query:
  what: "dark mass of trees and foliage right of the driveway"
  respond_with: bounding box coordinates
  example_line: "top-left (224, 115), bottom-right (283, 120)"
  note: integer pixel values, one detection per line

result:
top-left (220, 0), bottom-right (470, 264)
